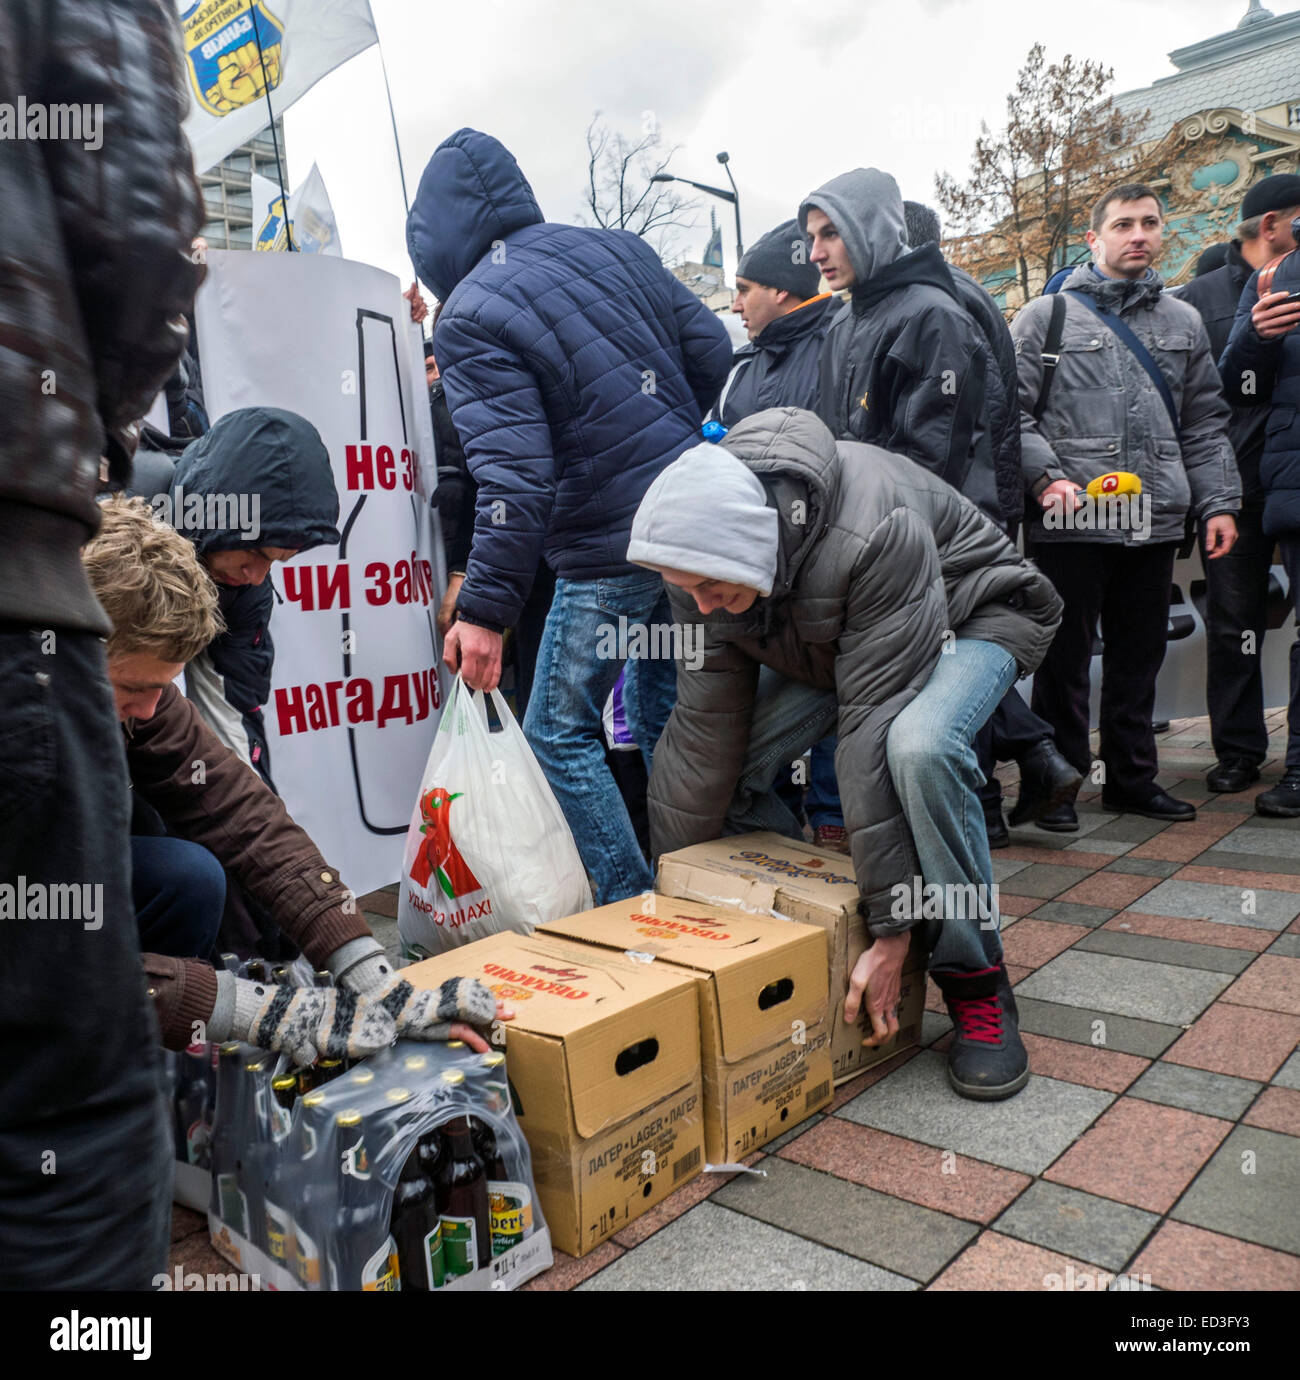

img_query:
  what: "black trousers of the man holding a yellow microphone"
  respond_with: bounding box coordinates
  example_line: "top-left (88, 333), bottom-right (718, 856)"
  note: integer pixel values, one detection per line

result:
top-left (1032, 541), bottom-right (1177, 800)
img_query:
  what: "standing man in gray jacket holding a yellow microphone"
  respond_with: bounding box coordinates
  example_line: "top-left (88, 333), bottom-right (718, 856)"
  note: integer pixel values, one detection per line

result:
top-left (1012, 184), bottom-right (1241, 834)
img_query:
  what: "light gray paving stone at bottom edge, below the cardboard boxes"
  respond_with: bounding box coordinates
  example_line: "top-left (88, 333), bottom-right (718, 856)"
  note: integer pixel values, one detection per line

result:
top-left (578, 1202), bottom-right (916, 1294)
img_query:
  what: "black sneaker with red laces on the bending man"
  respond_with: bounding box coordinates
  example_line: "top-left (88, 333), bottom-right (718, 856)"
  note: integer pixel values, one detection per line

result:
top-left (930, 963), bottom-right (1030, 1103)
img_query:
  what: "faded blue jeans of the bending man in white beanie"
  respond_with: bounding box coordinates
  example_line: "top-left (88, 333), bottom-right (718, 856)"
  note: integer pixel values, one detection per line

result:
top-left (726, 638), bottom-right (1016, 970)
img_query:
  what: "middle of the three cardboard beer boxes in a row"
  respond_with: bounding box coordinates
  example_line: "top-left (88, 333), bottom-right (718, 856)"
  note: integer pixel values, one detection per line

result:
top-left (544, 894), bottom-right (831, 1165)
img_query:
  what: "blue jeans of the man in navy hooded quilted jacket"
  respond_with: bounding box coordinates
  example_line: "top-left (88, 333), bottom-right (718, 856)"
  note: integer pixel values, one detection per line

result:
top-left (523, 570), bottom-right (678, 905)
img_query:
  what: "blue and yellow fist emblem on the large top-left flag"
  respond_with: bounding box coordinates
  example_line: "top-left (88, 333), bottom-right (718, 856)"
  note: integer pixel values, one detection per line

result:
top-left (181, 0), bottom-right (284, 116)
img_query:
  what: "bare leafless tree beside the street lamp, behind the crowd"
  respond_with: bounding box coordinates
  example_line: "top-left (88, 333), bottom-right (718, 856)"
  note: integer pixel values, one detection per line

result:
top-left (580, 110), bottom-right (698, 257)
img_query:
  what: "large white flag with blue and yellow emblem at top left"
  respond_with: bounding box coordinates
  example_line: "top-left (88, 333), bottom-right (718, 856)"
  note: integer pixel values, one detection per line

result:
top-left (177, 0), bottom-right (378, 173)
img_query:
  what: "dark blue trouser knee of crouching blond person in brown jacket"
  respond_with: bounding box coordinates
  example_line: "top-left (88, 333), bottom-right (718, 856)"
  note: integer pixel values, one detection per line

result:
top-left (131, 835), bottom-right (226, 958)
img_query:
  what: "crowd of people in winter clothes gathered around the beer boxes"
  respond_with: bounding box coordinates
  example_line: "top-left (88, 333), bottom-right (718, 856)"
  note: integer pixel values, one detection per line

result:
top-left (0, 0), bottom-right (1300, 1288)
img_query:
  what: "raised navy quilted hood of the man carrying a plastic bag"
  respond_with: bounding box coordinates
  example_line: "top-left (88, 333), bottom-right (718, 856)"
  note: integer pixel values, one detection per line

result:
top-left (406, 128), bottom-right (545, 302)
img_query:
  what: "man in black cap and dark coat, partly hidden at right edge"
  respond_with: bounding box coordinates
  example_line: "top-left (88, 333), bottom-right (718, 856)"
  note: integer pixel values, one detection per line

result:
top-left (1174, 173), bottom-right (1300, 792)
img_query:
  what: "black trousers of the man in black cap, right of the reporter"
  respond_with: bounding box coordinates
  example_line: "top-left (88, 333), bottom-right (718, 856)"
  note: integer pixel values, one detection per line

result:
top-left (1201, 508), bottom-right (1275, 763)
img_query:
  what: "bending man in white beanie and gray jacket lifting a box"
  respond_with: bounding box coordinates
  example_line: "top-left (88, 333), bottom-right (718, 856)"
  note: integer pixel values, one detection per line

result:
top-left (628, 407), bottom-right (1061, 1100)
